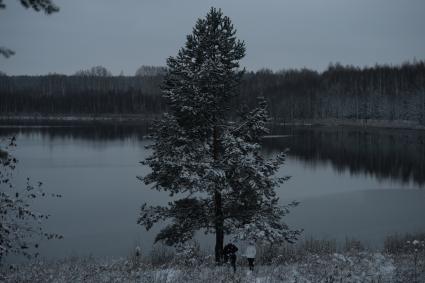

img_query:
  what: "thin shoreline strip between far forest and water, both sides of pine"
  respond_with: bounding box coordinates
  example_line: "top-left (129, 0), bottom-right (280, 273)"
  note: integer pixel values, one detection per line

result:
top-left (0, 114), bottom-right (425, 130)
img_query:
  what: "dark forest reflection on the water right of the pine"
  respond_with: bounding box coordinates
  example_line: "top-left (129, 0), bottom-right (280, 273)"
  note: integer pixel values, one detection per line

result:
top-left (264, 127), bottom-right (425, 186)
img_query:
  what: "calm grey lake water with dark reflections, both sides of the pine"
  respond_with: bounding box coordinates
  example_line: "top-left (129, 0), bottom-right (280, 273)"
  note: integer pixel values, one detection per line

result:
top-left (0, 123), bottom-right (425, 258)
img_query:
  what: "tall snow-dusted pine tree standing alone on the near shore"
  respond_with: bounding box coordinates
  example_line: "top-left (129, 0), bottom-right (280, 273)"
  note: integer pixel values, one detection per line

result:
top-left (138, 8), bottom-right (300, 262)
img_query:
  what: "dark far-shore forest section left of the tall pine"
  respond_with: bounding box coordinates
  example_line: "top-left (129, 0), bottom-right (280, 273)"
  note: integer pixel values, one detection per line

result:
top-left (0, 74), bottom-right (165, 115)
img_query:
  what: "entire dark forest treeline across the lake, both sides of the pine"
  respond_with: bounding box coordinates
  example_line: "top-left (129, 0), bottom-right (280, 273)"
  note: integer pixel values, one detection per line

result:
top-left (0, 61), bottom-right (425, 125)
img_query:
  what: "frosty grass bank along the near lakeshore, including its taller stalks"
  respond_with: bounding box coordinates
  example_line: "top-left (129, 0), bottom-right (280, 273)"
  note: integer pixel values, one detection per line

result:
top-left (0, 234), bottom-right (425, 283)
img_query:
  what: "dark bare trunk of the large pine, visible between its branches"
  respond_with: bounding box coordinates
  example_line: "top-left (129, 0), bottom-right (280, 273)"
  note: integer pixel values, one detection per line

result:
top-left (213, 126), bottom-right (224, 264)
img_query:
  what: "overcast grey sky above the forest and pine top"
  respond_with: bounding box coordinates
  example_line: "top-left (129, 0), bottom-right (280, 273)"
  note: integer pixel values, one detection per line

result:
top-left (0, 0), bottom-right (425, 75)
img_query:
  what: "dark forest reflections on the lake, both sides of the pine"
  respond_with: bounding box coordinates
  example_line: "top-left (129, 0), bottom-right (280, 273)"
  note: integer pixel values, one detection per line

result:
top-left (0, 122), bottom-right (425, 186)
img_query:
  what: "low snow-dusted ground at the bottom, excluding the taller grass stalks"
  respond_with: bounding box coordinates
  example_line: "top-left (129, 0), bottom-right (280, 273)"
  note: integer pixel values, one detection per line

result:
top-left (0, 252), bottom-right (425, 283)
